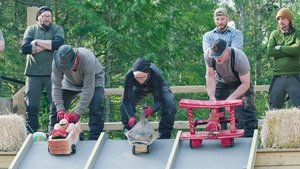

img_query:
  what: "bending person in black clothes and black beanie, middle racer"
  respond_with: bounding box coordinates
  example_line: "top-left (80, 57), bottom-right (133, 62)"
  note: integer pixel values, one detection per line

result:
top-left (121, 58), bottom-right (177, 139)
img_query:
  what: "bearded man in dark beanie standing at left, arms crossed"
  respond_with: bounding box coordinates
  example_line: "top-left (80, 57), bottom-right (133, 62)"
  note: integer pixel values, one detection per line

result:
top-left (22, 6), bottom-right (64, 133)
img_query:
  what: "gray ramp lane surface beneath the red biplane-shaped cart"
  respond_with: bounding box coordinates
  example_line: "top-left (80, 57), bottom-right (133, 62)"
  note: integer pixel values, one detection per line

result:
top-left (174, 138), bottom-right (252, 169)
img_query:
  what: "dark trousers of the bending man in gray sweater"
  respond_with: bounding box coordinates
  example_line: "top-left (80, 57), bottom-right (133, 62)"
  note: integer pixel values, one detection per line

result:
top-left (49, 87), bottom-right (105, 140)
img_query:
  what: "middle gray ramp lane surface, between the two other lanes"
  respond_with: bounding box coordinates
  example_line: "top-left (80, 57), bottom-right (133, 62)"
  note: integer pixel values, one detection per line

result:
top-left (94, 139), bottom-right (174, 169)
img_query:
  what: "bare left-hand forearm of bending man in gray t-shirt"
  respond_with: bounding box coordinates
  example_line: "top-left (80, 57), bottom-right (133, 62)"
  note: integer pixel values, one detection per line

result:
top-left (206, 66), bottom-right (216, 100)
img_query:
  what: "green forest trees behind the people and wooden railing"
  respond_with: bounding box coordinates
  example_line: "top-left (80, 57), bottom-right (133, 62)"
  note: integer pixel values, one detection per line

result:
top-left (0, 0), bottom-right (300, 135)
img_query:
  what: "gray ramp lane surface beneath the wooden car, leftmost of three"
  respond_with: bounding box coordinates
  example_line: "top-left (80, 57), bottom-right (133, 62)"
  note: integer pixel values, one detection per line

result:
top-left (19, 141), bottom-right (96, 169)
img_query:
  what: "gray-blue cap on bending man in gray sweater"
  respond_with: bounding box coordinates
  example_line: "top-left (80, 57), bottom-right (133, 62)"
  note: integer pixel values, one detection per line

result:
top-left (54, 45), bottom-right (76, 71)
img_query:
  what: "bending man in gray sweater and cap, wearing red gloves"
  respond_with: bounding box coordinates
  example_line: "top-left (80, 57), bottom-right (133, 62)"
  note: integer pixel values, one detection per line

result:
top-left (50, 45), bottom-right (105, 140)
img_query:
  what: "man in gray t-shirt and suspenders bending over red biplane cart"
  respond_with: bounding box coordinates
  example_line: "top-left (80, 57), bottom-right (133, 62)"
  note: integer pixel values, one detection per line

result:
top-left (204, 39), bottom-right (257, 137)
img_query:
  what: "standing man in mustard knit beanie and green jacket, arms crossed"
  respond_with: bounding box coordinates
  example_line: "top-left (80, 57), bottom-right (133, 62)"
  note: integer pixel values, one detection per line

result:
top-left (268, 8), bottom-right (300, 109)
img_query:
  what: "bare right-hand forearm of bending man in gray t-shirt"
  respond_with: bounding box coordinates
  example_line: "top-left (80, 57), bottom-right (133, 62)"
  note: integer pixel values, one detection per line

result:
top-left (227, 71), bottom-right (250, 100)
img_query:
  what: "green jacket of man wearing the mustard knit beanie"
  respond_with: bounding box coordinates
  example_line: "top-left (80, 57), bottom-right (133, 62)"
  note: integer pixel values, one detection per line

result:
top-left (267, 28), bottom-right (300, 75)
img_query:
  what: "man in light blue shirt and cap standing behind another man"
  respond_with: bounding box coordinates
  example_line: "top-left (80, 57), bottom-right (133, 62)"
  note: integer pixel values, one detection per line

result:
top-left (202, 8), bottom-right (244, 52)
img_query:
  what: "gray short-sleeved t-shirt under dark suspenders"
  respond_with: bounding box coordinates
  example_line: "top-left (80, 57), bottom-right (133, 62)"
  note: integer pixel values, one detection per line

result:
top-left (204, 48), bottom-right (250, 83)
